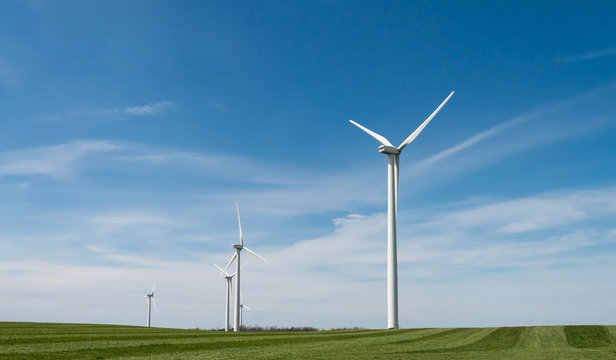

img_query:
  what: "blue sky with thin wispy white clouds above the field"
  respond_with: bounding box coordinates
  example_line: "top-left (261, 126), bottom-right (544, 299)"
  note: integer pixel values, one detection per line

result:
top-left (0, 1), bottom-right (616, 328)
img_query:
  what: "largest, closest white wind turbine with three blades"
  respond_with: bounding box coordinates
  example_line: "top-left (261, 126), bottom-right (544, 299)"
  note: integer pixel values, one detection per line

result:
top-left (349, 91), bottom-right (453, 329)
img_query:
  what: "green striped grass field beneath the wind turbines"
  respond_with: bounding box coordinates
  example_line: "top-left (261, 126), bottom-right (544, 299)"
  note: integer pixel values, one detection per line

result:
top-left (0, 322), bottom-right (616, 360)
